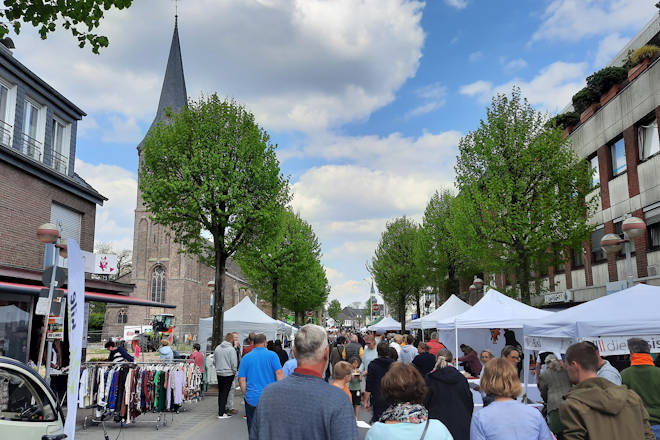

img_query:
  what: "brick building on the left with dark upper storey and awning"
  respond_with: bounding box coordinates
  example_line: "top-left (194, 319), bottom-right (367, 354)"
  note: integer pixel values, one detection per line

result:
top-left (0, 39), bottom-right (151, 365)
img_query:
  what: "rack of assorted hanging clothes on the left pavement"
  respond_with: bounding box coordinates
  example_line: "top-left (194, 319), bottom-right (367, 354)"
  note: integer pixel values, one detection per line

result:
top-left (78, 359), bottom-right (201, 429)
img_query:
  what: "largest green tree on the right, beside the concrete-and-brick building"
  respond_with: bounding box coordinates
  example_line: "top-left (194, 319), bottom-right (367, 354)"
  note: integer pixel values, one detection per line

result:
top-left (447, 88), bottom-right (598, 303)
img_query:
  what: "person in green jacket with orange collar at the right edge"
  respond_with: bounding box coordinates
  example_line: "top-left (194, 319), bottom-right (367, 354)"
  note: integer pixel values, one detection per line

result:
top-left (621, 338), bottom-right (660, 439)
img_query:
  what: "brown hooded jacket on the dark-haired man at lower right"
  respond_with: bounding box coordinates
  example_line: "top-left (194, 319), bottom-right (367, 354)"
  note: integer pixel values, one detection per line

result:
top-left (559, 377), bottom-right (655, 440)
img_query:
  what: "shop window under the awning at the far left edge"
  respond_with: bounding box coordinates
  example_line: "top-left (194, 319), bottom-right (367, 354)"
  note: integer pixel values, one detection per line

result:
top-left (0, 293), bottom-right (32, 362)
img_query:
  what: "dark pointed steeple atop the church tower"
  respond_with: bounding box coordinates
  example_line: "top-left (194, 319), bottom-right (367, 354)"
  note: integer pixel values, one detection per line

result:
top-left (138, 15), bottom-right (188, 150)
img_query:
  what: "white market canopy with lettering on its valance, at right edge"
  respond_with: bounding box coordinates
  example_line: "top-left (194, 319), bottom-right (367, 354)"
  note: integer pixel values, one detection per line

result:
top-left (524, 284), bottom-right (660, 352)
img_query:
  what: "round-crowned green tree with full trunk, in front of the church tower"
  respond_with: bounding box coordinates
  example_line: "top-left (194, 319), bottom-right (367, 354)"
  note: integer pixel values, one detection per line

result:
top-left (140, 94), bottom-right (289, 346)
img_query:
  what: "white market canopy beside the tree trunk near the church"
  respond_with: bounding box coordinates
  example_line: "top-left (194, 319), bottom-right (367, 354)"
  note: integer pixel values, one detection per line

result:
top-left (199, 296), bottom-right (291, 349)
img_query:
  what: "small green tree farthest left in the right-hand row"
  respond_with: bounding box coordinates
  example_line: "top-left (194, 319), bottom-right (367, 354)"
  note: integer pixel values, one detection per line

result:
top-left (367, 217), bottom-right (423, 331)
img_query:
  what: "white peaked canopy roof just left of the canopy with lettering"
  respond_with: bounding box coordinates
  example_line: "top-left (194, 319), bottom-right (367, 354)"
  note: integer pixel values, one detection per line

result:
top-left (436, 289), bottom-right (553, 329)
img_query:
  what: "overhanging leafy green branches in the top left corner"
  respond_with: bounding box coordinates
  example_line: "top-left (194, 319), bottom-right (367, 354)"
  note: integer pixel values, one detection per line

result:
top-left (0, 0), bottom-right (133, 54)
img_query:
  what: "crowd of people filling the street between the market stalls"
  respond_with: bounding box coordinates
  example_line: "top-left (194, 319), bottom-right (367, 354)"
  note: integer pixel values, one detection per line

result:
top-left (208, 324), bottom-right (660, 440)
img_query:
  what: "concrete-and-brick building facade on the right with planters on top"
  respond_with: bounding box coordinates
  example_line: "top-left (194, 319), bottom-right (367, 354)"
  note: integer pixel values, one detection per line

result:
top-left (534, 15), bottom-right (660, 304)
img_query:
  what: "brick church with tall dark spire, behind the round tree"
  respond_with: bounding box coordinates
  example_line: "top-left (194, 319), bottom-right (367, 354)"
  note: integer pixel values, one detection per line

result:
top-left (103, 18), bottom-right (258, 337)
